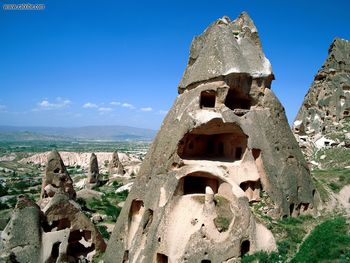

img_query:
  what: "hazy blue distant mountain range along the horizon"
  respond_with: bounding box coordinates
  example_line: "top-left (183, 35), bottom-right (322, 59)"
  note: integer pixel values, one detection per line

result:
top-left (0, 126), bottom-right (157, 141)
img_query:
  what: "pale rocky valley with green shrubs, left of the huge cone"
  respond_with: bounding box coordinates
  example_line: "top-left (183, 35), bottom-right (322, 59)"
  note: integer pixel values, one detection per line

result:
top-left (0, 144), bottom-right (147, 244)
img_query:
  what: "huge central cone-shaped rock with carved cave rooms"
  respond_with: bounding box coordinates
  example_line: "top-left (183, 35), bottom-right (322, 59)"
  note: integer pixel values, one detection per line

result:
top-left (104, 13), bottom-right (315, 262)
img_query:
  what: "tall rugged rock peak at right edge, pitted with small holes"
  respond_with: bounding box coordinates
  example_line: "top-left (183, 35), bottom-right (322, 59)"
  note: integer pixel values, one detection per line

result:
top-left (293, 38), bottom-right (350, 160)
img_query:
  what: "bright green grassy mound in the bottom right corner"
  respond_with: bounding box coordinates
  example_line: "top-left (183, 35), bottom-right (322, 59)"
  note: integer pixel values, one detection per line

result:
top-left (291, 217), bottom-right (350, 263)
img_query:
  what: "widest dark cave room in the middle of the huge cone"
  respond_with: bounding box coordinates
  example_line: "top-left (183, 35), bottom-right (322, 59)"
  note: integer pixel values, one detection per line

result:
top-left (177, 119), bottom-right (248, 162)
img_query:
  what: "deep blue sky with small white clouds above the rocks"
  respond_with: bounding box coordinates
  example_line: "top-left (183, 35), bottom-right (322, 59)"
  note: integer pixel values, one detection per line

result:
top-left (0, 0), bottom-right (350, 129)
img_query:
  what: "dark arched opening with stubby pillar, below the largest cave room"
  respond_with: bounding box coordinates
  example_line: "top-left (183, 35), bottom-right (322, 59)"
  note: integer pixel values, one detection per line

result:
top-left (177, 172), bottom-right (221, 195)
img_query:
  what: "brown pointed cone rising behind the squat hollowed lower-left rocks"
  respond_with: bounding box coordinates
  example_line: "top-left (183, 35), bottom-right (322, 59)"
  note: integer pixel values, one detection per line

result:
top-left (41, 151), bottom-right (76, 198)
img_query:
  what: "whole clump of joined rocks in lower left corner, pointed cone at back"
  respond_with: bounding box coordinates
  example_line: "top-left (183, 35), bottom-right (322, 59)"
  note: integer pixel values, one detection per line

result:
top-left (0, 151), bottom-right (106, 262)
